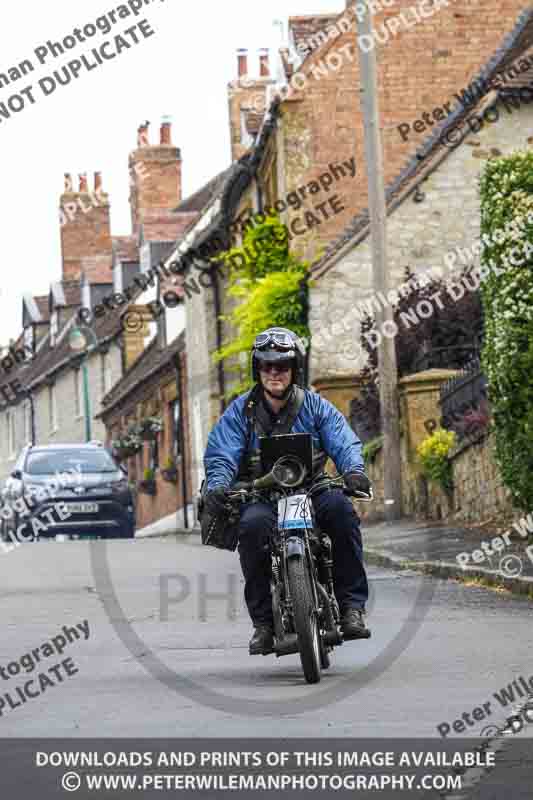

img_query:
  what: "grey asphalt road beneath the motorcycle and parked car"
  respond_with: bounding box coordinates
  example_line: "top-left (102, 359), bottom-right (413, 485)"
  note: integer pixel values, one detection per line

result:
top-left (0, 536), bottom-right (533, 738)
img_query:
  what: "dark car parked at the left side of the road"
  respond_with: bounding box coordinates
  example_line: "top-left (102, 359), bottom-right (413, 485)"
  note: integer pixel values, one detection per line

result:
top-left (5, 442), bottom-right (135, 539)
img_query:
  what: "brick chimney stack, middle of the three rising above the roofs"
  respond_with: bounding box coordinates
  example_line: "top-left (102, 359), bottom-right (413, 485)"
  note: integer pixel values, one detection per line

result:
top-left (129, 118), bottom-right (182, 234)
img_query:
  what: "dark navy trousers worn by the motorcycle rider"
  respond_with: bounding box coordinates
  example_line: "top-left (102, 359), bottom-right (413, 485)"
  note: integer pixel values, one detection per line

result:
top-left (239, 489), bottom-right (368, 625)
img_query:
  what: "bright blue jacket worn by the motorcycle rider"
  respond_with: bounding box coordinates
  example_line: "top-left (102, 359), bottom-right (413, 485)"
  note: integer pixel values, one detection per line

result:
top-left (204, 390), bottom-right (364, 491)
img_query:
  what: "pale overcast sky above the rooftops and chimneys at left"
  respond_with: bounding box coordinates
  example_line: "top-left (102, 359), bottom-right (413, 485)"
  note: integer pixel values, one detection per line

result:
top-left (0, 0), bottom-right (345, 344)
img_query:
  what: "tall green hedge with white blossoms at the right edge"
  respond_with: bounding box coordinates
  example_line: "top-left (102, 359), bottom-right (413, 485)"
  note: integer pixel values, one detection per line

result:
top-left (480, 152), bottom-right (533, 510)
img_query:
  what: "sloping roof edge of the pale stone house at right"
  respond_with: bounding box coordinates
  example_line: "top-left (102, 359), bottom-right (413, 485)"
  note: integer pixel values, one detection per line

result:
top-left (311, 9), bottom-right (533, 278)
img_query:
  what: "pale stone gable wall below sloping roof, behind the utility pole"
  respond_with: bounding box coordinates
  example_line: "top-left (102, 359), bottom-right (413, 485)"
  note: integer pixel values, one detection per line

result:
top-left (310, 104), bottom-right (533, 381)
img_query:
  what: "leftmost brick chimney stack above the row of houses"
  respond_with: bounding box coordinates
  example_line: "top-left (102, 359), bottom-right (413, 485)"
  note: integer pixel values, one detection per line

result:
top-left (59, 172), bottom-right (112, 282)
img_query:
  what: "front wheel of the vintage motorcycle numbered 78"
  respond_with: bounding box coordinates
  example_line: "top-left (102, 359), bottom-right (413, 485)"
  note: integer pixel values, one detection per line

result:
top-left (287, 556), bottom-right (321, 683)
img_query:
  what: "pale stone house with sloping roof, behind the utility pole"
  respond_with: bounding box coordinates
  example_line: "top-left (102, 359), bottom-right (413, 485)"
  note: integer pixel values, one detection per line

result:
top-left (310, 12), bottom-right (533, 413)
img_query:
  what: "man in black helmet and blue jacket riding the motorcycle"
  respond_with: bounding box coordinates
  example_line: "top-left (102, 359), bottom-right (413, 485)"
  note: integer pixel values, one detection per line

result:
top-left (204, 328), bottom-right (371, 655)
